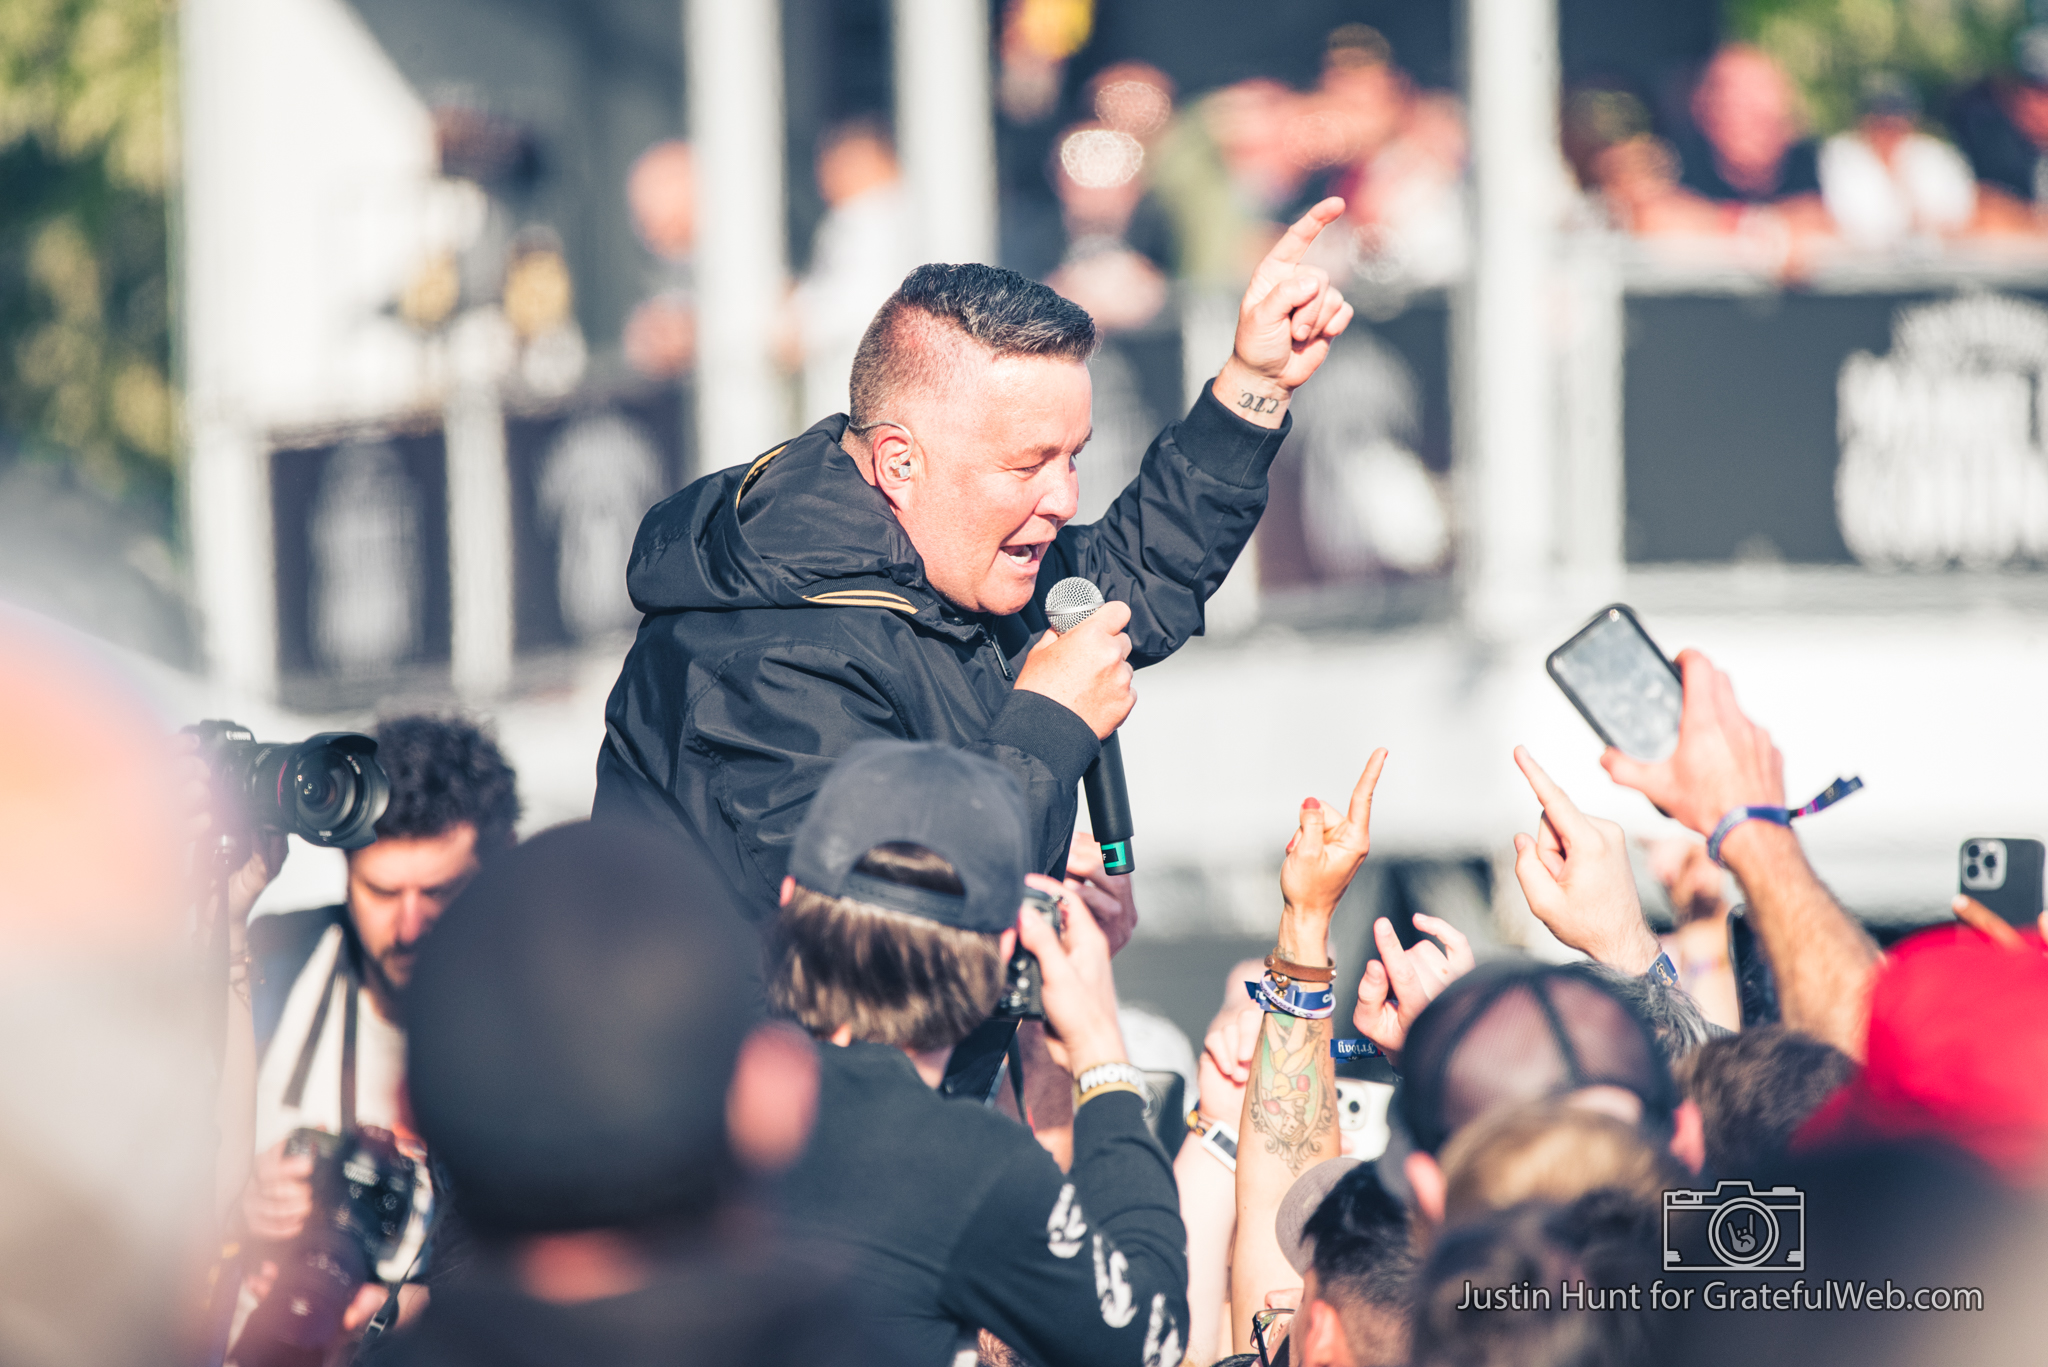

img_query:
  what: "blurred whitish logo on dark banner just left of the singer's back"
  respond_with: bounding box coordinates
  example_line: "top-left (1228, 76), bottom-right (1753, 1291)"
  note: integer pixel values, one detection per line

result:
top-left (539, 414), bottom-right (662, 637)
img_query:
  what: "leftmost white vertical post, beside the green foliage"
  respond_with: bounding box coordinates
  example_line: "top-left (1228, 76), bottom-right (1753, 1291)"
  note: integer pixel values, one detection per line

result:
top-left (178, 0), bottom-right (276, 697)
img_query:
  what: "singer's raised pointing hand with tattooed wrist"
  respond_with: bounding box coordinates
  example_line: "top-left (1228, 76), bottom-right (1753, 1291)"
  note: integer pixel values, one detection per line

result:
top-left (1217, 197), bottom-right (1352, 426)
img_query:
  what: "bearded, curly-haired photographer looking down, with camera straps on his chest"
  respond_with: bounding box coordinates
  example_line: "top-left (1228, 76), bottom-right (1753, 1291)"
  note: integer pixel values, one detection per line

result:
top-left (215, 717), bottom-right (518, 1367)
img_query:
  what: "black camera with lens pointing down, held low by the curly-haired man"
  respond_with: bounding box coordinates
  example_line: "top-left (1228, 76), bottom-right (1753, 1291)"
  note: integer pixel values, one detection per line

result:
top-left (233, 1125), bottom-right (414, 1367)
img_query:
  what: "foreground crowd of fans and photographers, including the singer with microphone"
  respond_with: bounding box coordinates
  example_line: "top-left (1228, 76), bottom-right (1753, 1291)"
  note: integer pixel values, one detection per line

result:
top-left (12, 136), bottom-right (2048, 1367)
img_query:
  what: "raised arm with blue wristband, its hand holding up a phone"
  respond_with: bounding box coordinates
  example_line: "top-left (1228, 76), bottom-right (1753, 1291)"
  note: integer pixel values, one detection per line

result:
top-left (1599, 650), bottom-right (1878, 1062)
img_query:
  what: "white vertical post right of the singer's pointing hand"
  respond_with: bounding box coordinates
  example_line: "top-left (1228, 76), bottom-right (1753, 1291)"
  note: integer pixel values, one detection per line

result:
top-left (1454, 0), bottom-right (1561, 635)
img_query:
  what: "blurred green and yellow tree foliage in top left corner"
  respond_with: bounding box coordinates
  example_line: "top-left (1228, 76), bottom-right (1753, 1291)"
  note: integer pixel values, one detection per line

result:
top-left (0, 0), bottom-right (176, 535)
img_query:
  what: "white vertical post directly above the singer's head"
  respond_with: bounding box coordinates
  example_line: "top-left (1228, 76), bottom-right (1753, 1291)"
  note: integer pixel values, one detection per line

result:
top-left (895, 0), bottom-right (995, 262)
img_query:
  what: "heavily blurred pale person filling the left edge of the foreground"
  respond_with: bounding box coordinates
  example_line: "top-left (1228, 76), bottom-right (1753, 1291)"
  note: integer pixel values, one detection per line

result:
top-left (0, 607), bottom-right (214, 1367)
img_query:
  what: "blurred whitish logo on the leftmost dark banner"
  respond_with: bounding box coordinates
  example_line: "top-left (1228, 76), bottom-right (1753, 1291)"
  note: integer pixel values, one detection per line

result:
top-left (311, 443), bottom-right (420, 674)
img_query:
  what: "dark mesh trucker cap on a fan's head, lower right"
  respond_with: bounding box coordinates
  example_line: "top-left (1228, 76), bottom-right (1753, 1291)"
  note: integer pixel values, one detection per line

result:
top-left (1382, 959), bottom-right (1679, 1166)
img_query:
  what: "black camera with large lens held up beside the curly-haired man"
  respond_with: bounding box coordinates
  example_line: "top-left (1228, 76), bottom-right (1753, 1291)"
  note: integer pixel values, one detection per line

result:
top-left (184, 721), bottom-right (391, 851)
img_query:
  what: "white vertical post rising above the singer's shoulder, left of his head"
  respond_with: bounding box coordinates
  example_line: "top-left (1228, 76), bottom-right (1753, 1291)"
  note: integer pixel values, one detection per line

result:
top-left (684, 0), bottom-right (791, 473)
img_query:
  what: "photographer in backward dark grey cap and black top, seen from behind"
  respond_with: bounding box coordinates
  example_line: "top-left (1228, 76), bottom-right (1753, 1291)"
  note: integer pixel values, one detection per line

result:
top-left (768, 742), bottom-right (1188, 1367)
